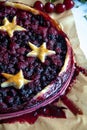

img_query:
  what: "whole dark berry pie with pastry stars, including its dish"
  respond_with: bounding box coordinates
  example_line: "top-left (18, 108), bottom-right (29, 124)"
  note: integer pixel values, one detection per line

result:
top-left (0, 2), bottom-right (75, 120)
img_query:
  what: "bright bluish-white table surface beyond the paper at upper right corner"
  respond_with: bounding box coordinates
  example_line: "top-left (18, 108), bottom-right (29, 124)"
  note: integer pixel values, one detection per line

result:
top-left (72, 0), bottom-right (87, 57)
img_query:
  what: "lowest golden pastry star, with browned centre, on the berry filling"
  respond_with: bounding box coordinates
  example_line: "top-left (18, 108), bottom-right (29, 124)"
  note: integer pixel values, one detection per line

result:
top-left (1, 70), bottom-right (30, 89)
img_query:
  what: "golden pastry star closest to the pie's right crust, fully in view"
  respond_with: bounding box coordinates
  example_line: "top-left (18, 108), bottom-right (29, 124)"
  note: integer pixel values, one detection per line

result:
top-left (27, 42), bottom-right (56, 62)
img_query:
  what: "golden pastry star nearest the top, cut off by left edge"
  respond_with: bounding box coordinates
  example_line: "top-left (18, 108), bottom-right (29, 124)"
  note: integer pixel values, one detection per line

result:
top-left (0, 16), bottom-right (26, 37)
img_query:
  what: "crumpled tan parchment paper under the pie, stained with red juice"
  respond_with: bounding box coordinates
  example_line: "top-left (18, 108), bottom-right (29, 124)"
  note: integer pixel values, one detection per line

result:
top-left (0, 0), bottom-right (87, 130)
